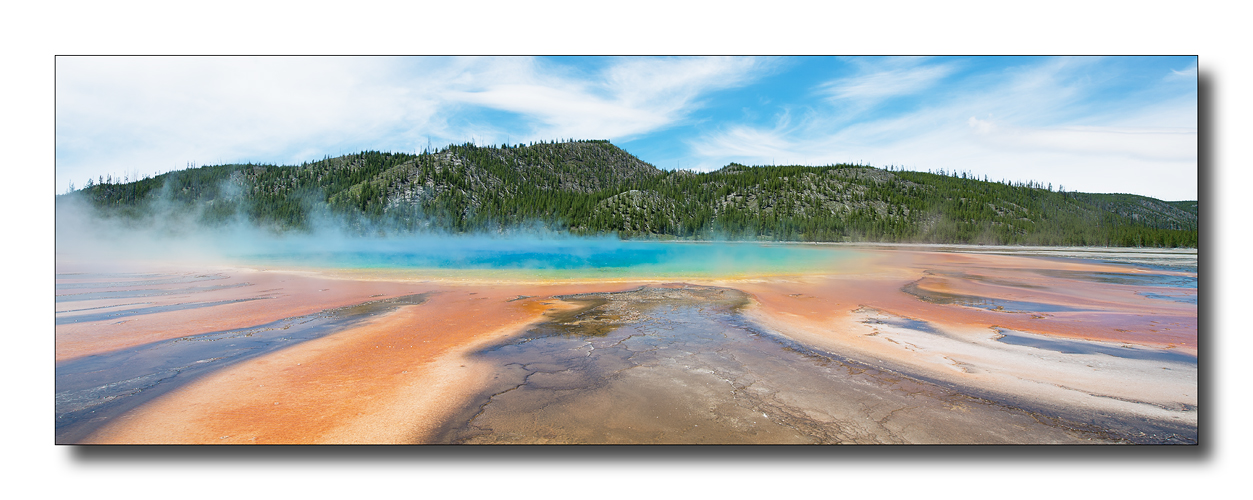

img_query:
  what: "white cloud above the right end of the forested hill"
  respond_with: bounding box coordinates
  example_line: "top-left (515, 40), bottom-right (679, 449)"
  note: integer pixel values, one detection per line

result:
top-left (689, 59), bottom-right (1197, 199)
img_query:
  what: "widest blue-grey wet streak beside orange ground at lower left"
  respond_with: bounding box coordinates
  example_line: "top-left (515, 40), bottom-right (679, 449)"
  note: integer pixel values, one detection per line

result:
top-left (56, 294), bottom-right (426, 444)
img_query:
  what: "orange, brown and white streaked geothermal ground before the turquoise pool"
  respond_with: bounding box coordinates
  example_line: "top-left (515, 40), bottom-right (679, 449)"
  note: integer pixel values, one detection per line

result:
top-left (55, 247), bottom-right (1198, 444)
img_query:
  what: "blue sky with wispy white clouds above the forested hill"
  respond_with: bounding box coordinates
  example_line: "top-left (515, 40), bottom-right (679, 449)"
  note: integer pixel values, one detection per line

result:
top-left (55, 56), bottom-right (1198, 201)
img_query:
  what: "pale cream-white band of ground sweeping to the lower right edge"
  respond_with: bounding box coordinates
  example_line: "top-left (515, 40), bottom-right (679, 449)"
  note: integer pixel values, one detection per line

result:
top-left (837, 306), bottom-right (1197, 444)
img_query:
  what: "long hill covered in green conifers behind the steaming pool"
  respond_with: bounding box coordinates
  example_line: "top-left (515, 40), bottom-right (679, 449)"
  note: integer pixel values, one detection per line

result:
top-left (58, 140), bottom-right (1198, 247)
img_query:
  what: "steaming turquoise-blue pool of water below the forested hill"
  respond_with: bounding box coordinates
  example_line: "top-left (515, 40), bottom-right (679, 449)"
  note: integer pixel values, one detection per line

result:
top-left (237, 238), bottom-right (857, 276)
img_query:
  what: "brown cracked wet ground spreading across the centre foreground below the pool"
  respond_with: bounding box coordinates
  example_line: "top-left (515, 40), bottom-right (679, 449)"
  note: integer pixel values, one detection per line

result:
top-left (436, 286), bottom-right (1123, 444)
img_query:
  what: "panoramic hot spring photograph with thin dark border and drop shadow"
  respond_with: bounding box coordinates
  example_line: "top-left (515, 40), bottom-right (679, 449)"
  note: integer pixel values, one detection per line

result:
top-left (55, 55), bottom-right (1208, 446)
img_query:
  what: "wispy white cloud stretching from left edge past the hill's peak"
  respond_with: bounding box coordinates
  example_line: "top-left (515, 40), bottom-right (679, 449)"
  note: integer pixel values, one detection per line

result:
top-left (56, 58), bottom-right (769, 189)
